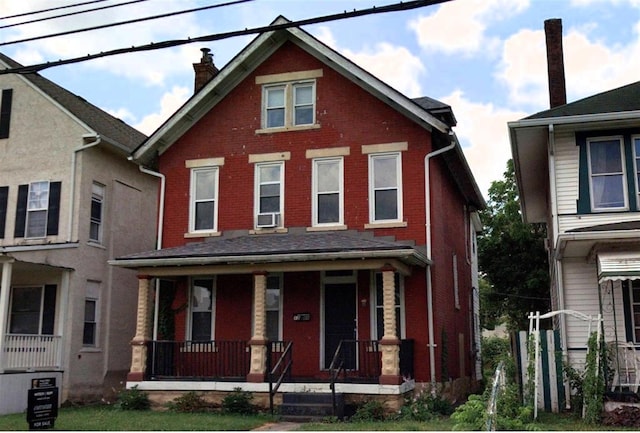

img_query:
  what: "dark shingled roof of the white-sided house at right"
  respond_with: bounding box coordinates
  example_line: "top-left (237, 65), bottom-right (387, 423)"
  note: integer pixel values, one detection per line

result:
top-left (525, 81), bottom-right (640, 119)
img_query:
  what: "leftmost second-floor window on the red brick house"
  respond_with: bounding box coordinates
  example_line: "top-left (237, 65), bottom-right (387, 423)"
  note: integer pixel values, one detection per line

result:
top-left (190, 167), bottom-right (218, 232)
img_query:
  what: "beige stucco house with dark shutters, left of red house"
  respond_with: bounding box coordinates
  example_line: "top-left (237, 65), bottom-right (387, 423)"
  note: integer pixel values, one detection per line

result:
top-left (0, 55), bottom-right (158, 413)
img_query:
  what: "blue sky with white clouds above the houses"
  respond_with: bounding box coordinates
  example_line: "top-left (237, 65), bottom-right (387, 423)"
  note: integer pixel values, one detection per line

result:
top-left (0, 0), bottom-right (640, 199)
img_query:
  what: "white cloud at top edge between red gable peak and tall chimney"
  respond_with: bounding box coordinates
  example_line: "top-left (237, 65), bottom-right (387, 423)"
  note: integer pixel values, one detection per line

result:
top-left (409, 0), bottom-right (529, 55)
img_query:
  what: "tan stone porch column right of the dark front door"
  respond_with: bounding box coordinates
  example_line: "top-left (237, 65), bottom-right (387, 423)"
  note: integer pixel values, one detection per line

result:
top-left (380, 266), bottom-right (402, 385)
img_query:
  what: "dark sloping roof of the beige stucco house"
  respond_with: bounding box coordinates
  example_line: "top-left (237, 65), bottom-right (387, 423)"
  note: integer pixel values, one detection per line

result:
top-left (0, 53), bottom-right (147, 152)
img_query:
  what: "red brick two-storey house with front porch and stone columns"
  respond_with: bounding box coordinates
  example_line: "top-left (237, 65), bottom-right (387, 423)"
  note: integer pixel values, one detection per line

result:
top-left (111, 17), bottom-right (484, 408)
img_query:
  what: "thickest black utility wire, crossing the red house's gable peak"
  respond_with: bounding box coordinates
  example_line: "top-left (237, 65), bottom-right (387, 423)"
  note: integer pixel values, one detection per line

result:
top-left (0, 0), bottom-right (450, 75)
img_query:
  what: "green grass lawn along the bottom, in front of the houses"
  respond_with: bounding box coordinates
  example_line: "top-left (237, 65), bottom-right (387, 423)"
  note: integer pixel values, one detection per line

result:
top-left (0, 406), bottom-right (637, 431)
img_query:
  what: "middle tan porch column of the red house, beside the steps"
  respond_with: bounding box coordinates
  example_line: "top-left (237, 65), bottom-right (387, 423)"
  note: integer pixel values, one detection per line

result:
top-left (247, 272), bottom-right (267, 382)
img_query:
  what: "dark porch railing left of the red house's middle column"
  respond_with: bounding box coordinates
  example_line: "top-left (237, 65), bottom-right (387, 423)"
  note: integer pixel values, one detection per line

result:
top-left (145, 340), bottom-right (251, 380)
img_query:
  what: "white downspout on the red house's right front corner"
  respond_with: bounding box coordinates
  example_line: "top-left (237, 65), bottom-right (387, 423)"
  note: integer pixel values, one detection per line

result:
top-left (424, 130), bottom-right (456, 388)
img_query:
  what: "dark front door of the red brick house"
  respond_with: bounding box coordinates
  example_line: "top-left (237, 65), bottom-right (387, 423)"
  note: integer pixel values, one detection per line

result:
top-left (324, 283), bottom-right (356, 369)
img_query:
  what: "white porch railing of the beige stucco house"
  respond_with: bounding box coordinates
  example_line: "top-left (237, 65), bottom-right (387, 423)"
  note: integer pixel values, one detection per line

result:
top-left (0, 334), bottom-right (62, 370)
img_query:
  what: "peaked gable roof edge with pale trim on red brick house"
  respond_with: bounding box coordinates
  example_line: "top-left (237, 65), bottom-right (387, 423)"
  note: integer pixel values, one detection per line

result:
top-left (133, 16), bottom-right (452, 165)
